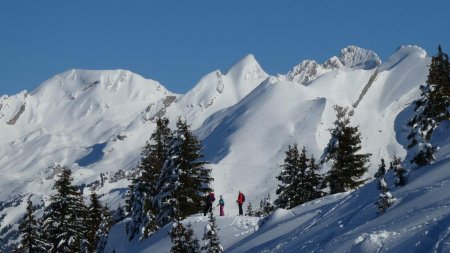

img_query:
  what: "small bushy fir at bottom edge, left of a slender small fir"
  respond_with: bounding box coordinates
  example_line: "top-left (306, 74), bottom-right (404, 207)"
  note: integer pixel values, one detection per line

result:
top-left (169, 217), bottom-right (200, 253)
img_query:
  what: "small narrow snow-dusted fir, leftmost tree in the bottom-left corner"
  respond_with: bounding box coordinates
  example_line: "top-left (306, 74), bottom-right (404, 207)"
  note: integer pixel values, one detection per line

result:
top-left (18, 196), bottom-right (49, 253)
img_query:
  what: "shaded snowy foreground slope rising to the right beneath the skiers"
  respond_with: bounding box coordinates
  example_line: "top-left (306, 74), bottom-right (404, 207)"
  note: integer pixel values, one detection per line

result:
top-left (107, 135), bottom-right (450, 253)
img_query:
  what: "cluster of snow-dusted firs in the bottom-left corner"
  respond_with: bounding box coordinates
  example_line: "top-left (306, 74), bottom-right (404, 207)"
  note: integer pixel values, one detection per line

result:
top-left (18, 167), bottom-right (113, 252)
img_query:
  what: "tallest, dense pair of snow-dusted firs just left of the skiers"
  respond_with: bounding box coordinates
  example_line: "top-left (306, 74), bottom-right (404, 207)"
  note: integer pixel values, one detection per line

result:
top-left (126, 118), bottom-right (213, 240)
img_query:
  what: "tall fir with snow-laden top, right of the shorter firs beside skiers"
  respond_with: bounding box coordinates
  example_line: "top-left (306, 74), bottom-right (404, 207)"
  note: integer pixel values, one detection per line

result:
top-left (321, 105), bottom-right (371, 194)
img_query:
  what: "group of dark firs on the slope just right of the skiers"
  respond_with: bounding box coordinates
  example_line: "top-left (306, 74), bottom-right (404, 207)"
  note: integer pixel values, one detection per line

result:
top-left (275, 106), bottom-right (370, 209)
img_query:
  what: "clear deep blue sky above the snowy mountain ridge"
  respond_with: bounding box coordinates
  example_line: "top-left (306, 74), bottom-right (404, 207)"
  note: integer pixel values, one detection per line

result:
top-left (0, 0), bottom-right (450, 95)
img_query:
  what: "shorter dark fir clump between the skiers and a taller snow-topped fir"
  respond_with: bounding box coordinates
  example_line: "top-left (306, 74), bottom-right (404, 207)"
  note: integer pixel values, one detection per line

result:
top-left (275, 144), bottom-right (322, 209)
